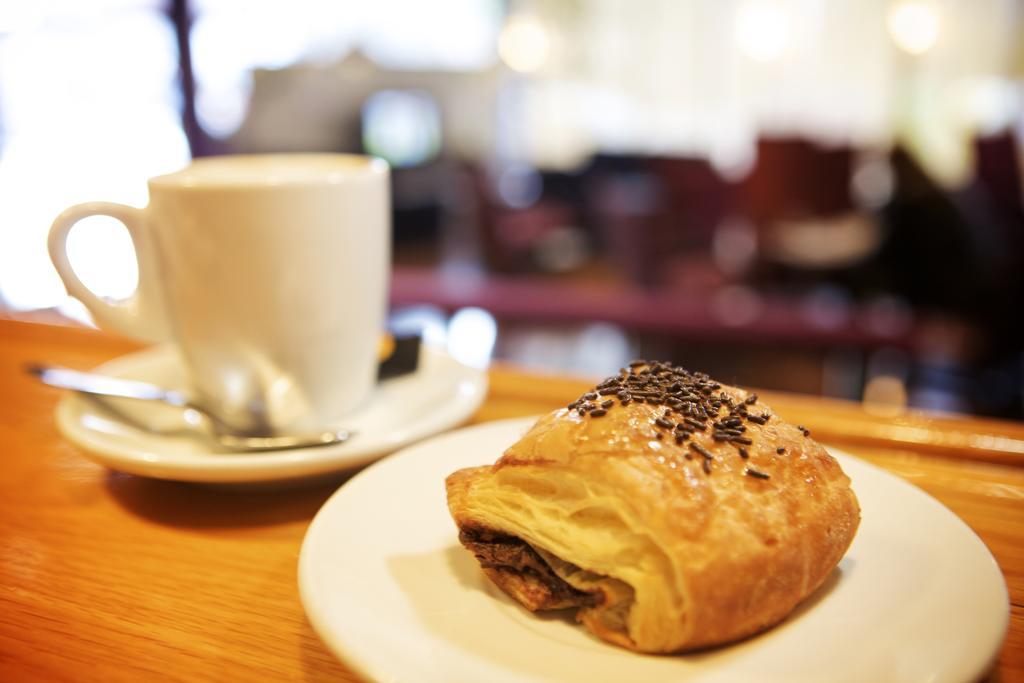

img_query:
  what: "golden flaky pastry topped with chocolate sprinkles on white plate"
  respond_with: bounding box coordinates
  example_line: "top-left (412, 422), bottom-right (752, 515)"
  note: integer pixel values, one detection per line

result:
top-left (445, 361), bottom-right (860, 652)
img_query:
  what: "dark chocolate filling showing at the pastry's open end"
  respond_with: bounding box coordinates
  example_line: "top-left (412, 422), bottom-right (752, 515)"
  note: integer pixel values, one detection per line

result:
top-left (459, 528), bottom-right (603, 609)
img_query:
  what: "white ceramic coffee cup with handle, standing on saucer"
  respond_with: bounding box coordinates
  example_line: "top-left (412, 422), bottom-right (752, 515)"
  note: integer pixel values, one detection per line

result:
top-left (49, 155), bottom-right (391, 433)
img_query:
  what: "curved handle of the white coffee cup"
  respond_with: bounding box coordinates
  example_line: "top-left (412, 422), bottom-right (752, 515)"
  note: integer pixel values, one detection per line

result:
top-left (47, 202), bottom-right (170, 342)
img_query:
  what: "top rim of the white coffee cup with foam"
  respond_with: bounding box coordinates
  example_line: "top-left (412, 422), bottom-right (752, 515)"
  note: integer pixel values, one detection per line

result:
top-left (150, 153), bottom-right (390, 189)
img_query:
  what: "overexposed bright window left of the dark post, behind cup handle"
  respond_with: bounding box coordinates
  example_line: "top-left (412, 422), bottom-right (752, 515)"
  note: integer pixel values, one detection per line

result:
top-left (0, 0), bottom-right (188, 308)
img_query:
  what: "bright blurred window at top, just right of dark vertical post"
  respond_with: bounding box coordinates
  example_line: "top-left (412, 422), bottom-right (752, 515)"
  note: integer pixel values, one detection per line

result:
top-left (191, 0), bottom-right (504, 137)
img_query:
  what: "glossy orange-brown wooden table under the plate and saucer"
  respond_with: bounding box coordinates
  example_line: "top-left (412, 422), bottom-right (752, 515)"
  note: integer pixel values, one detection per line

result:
top-left (0, 321), bottom-right (1024, 683)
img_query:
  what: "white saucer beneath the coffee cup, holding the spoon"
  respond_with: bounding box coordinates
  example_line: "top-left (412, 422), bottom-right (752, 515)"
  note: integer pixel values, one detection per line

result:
top-left (56, 345), bottom-right (487, 483)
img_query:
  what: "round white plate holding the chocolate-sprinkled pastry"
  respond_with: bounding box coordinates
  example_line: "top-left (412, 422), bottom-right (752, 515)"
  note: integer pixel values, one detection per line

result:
top-left (299, 420), bottom-right (1008, 683)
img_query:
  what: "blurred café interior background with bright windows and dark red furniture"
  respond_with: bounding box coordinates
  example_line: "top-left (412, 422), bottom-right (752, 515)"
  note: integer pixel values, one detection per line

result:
top-left (0, 0), bottom-right (1024, 419)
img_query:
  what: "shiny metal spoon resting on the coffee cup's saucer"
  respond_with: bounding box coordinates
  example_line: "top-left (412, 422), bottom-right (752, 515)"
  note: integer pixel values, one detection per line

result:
top-left (26, 365), bottom-right (352, 451)
